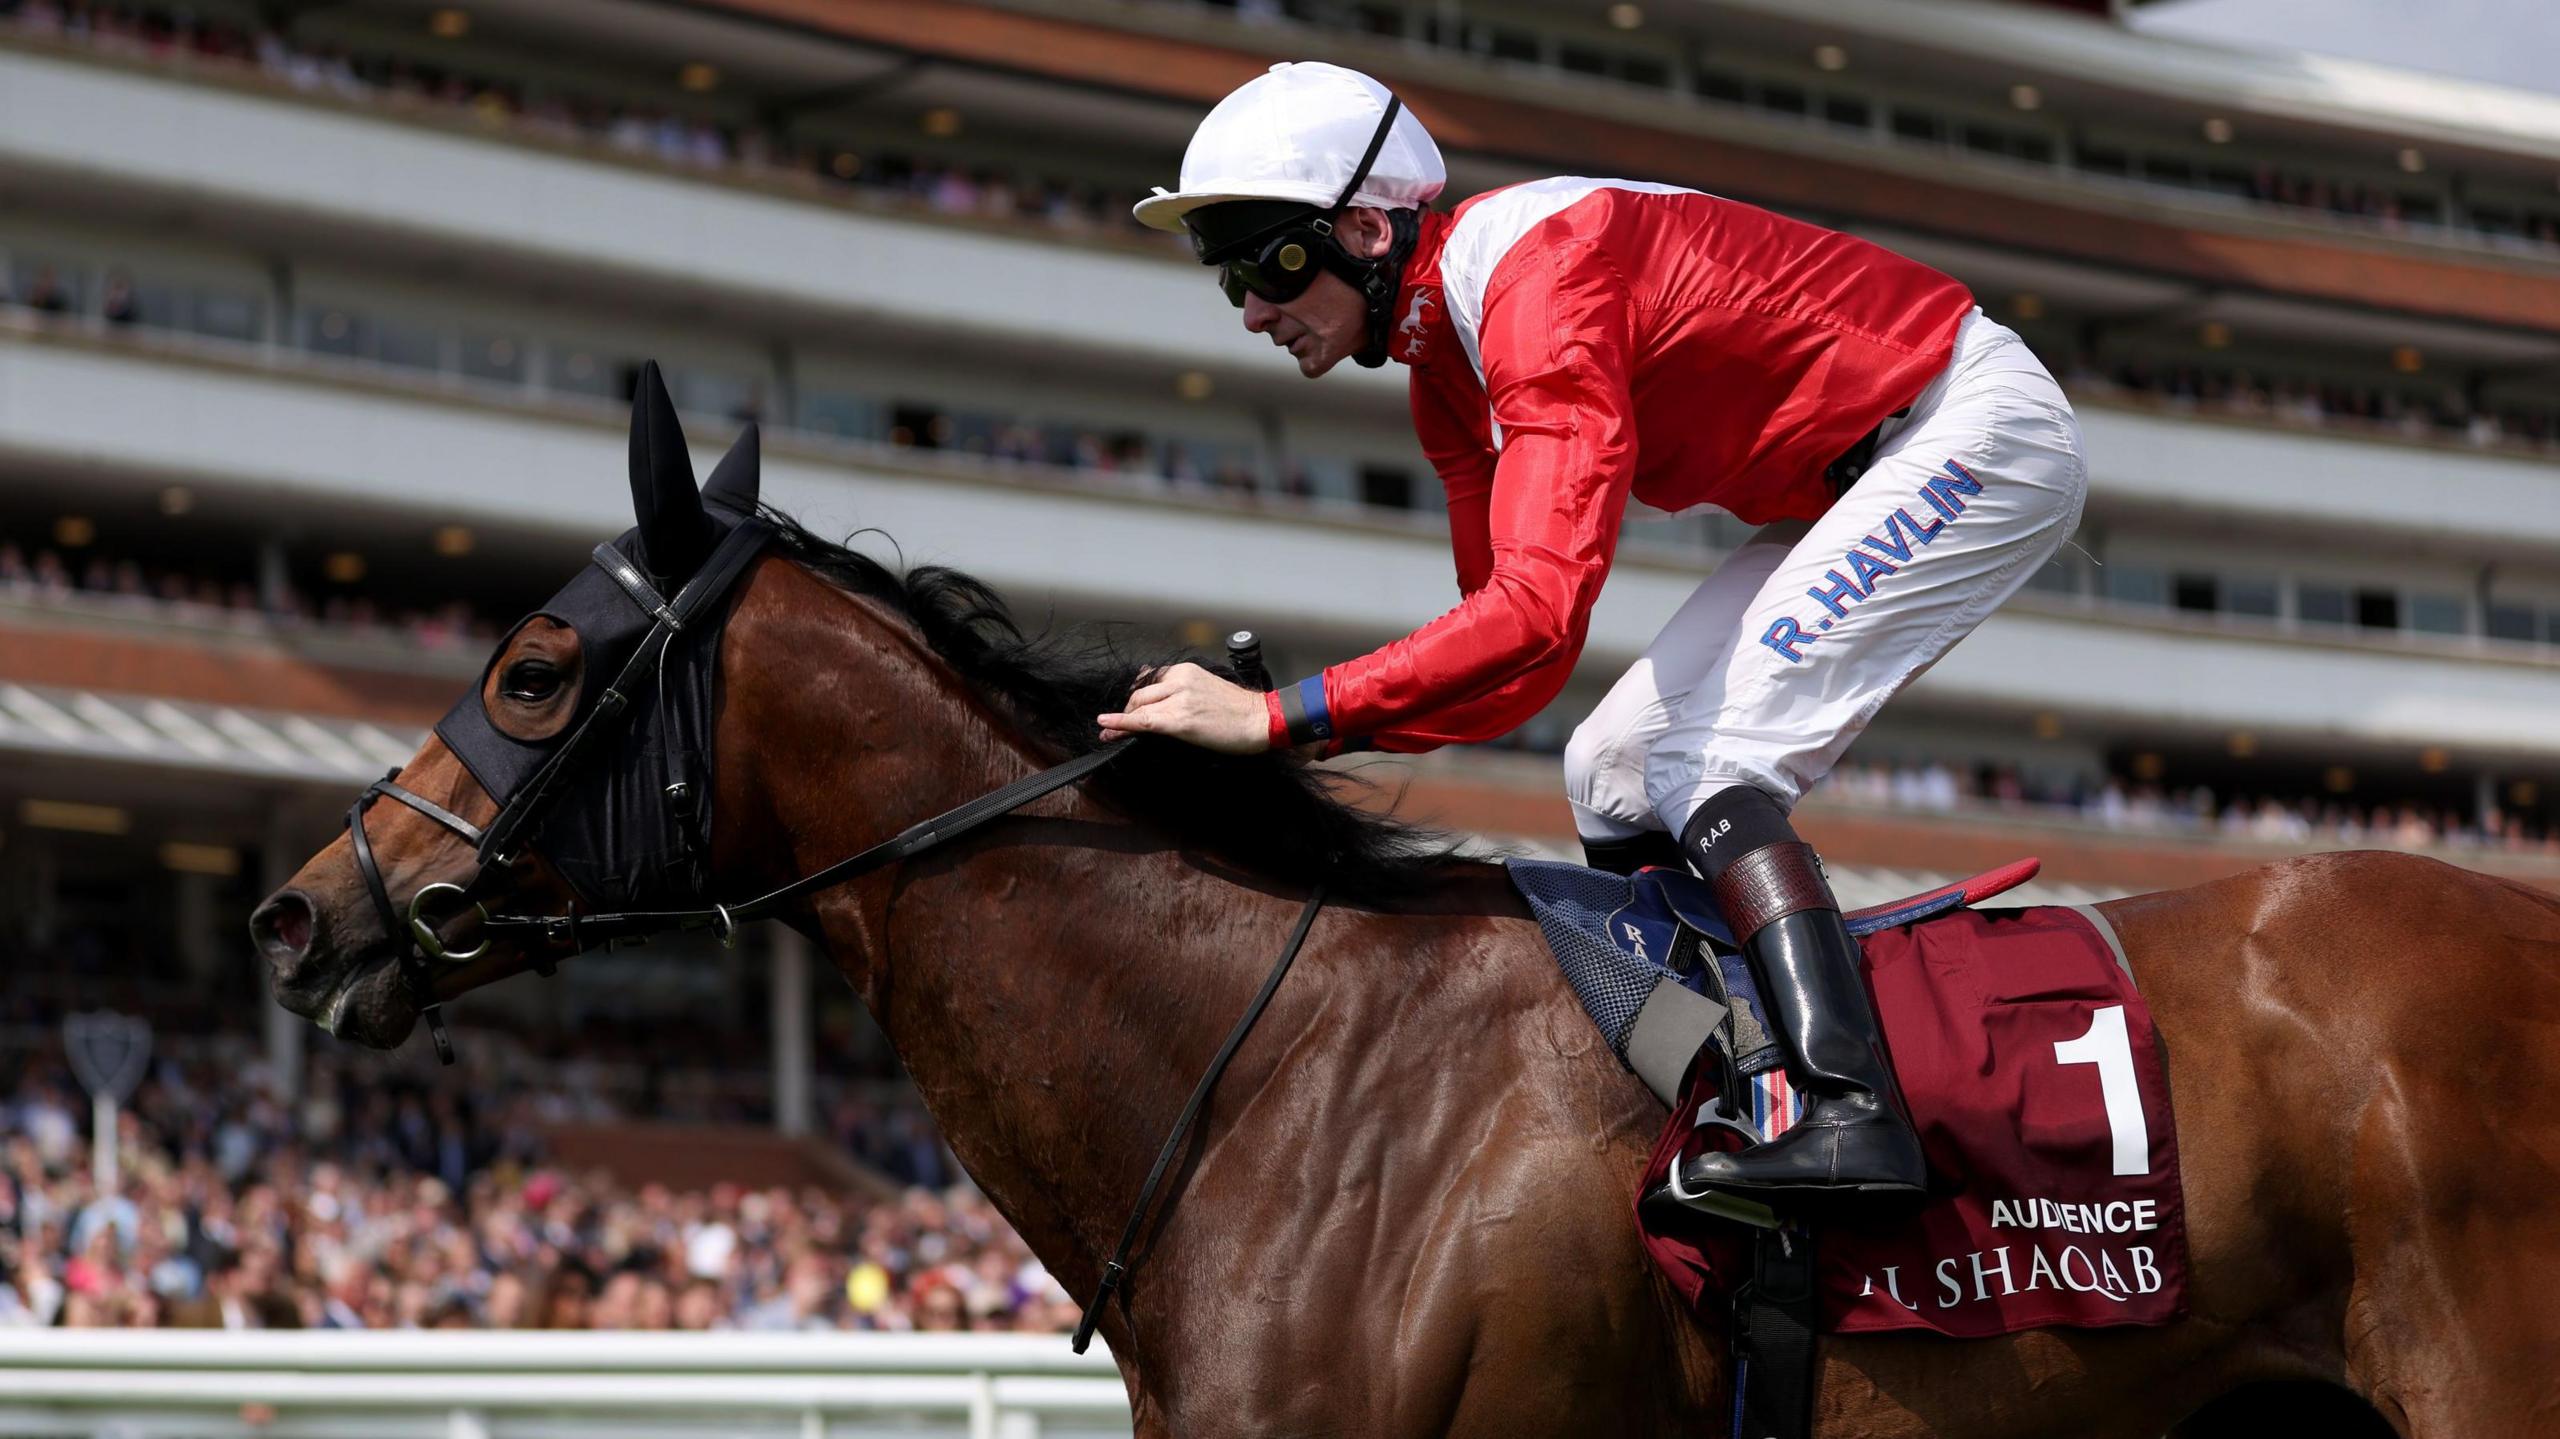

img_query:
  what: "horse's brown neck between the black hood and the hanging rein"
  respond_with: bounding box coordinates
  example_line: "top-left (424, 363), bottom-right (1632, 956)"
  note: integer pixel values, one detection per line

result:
top-left (732, 591), bottom-right (1303, 1321)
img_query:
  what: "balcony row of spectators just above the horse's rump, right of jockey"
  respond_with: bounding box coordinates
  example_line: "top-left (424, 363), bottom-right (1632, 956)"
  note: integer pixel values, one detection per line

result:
top-left (1818, 758), bottom-right (2560, 855)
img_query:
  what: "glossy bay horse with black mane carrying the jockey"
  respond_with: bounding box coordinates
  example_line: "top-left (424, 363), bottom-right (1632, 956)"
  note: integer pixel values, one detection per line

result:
top-left (251, 394), bottom-right (2560, 1439)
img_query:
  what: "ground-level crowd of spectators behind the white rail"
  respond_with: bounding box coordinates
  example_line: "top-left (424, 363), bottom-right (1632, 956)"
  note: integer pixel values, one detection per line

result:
top-left (0, 1037), bottom-right (1075, 1331)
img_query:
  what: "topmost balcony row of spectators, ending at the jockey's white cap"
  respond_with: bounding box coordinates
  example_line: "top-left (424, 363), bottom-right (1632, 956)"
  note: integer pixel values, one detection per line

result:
top-left (0, 0), bottom-right (1160, 241)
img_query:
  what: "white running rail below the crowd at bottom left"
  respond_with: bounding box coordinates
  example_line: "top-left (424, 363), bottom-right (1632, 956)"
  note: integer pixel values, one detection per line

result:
top-left (0, 1329), bottom-right (1129, 1439)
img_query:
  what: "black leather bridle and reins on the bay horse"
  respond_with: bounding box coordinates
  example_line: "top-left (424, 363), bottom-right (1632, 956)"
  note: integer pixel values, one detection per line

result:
top-left (346, 520), bottom-right (1324, 1355)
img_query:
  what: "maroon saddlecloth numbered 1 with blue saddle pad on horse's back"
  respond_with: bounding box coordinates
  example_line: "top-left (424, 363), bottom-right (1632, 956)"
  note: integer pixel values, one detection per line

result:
top-left (1510, 860), bottom-right (2184, 1439)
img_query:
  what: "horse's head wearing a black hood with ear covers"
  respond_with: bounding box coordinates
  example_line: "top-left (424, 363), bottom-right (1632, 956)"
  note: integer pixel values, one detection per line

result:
top-left (248, 366), bottom-right (763, 1047)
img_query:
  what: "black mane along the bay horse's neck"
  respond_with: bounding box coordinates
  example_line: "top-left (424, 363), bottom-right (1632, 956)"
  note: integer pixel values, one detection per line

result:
top-left (760, 504), bottom-right (1457, 901)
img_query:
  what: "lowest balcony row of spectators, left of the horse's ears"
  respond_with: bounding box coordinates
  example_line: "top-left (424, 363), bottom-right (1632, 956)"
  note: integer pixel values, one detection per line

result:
top-left (0, 540), bottom-right (499, 650)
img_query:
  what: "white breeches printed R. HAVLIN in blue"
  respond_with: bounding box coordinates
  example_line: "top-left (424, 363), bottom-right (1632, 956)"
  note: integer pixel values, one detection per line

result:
top-left (1564, 310), bottom-right (2089, 840)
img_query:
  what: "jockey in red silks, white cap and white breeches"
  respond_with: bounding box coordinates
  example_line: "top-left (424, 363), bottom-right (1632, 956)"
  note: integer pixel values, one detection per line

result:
top-left (1098, 64), bottom-right (2086, 1198)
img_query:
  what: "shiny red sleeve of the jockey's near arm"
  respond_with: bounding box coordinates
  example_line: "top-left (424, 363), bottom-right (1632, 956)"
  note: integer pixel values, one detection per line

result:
top-left (1324, 230), bottom-right (1636, 753)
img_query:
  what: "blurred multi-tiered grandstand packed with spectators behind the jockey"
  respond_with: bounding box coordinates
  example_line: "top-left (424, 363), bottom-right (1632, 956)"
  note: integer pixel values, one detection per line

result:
top-left (0, 0), bottom-right (2560, 1326)
